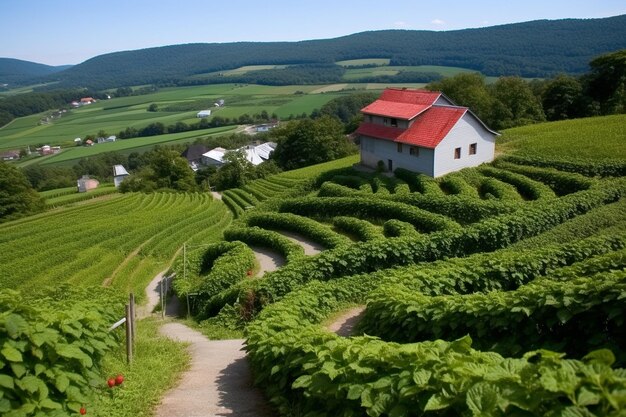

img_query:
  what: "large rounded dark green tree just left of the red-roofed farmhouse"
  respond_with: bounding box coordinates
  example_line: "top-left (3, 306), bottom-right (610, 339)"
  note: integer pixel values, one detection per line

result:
top-left (271, 116), bottom-right (357, 169)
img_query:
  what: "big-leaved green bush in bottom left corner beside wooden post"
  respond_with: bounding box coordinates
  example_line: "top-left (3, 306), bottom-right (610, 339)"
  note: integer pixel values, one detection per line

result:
top-left (0, 286), bottom-right (123, 417)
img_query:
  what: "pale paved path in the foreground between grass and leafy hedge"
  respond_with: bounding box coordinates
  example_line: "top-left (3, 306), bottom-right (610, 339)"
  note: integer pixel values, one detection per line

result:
top-left (155, 323), bottom-right (272, 417)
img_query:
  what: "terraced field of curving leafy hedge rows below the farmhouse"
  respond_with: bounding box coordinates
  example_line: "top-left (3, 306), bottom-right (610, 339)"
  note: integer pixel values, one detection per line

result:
top-left (178, 152), bottom-right (626, 416)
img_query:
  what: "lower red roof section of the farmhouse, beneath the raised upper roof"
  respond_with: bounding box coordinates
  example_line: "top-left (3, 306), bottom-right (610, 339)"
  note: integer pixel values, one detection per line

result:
top-left (357, 106), bottom-right (467, 149)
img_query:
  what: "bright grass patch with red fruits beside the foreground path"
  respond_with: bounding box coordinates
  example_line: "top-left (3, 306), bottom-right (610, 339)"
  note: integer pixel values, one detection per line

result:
top-left (90, 318), bottom-right (190, 417)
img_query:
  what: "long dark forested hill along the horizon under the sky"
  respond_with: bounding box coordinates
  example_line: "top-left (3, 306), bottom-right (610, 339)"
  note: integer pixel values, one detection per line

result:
top-left (26, 15), bottom-right (626, 88)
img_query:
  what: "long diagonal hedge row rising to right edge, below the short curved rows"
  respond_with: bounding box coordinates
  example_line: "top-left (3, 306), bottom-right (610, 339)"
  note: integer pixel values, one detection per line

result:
top-left (235, 182), bottom-right (625, 312)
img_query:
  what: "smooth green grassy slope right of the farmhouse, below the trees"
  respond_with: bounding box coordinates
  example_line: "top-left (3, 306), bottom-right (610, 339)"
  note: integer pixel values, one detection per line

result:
top-left (498, 114), bottom-right (626, 161)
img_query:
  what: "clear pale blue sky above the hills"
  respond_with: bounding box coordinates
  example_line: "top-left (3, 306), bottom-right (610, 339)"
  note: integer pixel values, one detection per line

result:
top-left (0, 0), bottom-right (626, 65)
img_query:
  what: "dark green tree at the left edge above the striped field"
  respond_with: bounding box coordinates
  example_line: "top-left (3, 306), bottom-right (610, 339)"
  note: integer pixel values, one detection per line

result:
top-left (0, 162), bottom-right (45, 223)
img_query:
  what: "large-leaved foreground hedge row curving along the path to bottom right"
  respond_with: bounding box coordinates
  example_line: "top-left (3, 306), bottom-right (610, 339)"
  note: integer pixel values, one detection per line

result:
top-left (246, 258), bottom-right (626, 417)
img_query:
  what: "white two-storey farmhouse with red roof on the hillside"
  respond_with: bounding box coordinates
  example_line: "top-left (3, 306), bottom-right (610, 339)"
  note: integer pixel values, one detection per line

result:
top-left (356, 88), bottom-right (498, 177)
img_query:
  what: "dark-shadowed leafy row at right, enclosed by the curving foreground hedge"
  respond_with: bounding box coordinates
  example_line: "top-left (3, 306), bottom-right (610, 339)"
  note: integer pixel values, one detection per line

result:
top-left (364, 262), bottom-right (626, 364)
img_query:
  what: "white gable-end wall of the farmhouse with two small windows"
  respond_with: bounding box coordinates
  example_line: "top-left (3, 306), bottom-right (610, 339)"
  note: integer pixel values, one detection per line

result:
top-left (433, 112), bottom-right (496, 177)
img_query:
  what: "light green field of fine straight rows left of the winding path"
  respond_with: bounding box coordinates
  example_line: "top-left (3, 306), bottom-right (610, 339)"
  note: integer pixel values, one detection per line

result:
top-left (0, 193), bottom-right (232, 298)
